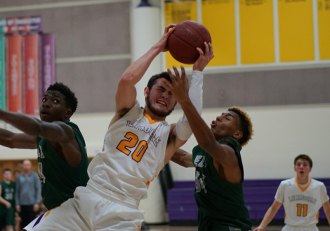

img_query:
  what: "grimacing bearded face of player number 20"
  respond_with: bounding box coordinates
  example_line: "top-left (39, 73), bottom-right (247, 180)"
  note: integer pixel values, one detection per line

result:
top-left (146, 78), bottom-right (177, 117)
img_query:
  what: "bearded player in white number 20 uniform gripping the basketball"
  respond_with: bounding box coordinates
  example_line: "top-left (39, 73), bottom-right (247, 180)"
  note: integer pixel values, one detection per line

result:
top-left (26, 25), bottom-right (214, 231)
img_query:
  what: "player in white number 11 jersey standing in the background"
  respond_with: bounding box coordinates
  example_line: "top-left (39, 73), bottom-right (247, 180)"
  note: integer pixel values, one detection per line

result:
top-left (254, 154), bottom-right (330, 231)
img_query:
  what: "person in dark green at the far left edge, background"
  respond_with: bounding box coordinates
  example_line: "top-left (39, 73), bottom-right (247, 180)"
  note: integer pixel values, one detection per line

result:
top-left (0, 168), bottom-right (15, 231)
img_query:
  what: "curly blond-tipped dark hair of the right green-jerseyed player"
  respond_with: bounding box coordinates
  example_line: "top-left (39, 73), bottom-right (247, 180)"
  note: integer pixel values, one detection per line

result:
top-left (228, 106), bottom-right (253, 146)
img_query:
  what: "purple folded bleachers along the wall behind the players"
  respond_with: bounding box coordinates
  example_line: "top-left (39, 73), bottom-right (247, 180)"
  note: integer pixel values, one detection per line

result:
top-left (167, 178), bottom-right (330, 225)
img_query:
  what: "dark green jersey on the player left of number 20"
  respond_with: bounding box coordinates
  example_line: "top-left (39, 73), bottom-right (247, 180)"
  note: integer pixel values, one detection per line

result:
top-left (37, 122), bottom-right (88, 209)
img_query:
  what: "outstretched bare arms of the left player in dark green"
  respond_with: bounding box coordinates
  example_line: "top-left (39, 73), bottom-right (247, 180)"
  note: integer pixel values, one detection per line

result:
top-left (0, 110), bottom-right (81, 166)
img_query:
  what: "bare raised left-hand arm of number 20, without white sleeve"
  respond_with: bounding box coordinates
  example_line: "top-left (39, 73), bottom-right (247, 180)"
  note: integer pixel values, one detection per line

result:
top-left (112, 24), bottom-right (174, 123)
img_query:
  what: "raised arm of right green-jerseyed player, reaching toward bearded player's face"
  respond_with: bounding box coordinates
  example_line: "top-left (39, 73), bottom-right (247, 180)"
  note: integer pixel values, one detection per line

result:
top-left (168, 68), bottom-right (241, 183)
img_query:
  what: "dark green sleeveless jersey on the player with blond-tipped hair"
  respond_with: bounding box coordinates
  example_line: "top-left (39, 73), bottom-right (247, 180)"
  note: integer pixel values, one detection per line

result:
top-left (193, 137), bottom-right (252, 231)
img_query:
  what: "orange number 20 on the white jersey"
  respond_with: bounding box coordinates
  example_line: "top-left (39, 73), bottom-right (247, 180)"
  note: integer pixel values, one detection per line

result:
top-left (116, 132), bottom-right (148, 162)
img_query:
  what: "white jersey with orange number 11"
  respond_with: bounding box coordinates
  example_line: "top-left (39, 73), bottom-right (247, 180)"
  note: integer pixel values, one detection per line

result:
top-left (275, 178), bottom-right (329, 227)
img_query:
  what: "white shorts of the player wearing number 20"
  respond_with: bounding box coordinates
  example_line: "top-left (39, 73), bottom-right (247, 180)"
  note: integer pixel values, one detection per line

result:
top-left (24, 187), bottom-right (143, 231)
